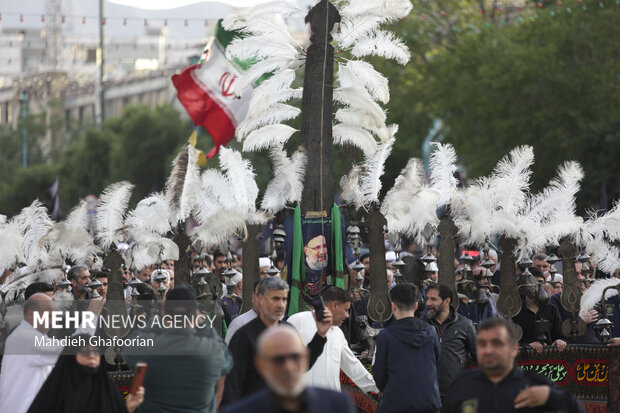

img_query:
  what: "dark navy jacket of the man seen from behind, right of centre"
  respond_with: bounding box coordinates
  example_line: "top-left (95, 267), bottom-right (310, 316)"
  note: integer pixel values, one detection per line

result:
top-left (372, 317), bottom-right (441, 413)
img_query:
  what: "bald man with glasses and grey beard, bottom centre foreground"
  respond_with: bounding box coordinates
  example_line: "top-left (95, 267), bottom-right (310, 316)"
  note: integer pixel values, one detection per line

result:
top-left (222, 325), bottom-right (355, 413)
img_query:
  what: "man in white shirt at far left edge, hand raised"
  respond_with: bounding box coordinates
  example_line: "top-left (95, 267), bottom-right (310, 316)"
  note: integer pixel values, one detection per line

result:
top-left (0, 293), bottom-right (104, 413)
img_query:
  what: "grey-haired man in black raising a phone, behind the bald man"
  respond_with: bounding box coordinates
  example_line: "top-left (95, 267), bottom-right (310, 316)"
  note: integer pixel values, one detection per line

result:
top-left (222, 277), bottom-right (332, 405)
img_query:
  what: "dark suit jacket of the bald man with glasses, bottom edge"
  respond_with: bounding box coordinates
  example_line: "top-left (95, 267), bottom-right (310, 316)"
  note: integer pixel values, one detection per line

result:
top-left (222, 387), bottom-right (355, 413)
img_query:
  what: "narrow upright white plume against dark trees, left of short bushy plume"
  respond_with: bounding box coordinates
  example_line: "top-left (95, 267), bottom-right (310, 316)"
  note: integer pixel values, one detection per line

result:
top-left (95, 181), bottom-right (133, 250)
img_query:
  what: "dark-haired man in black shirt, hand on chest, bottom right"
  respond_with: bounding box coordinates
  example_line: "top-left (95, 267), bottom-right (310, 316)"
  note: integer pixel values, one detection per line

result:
top-left (442, 318), bottom-right (585, 413)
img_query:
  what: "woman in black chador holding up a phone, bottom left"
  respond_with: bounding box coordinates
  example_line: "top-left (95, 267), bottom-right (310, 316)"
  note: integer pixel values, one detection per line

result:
top-left (28, 334), bottom-right (144, 413)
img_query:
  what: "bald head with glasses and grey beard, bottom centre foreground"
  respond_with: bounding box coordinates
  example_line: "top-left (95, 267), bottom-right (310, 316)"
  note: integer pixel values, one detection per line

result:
top-left (255, 325), bottom-right (309, 397)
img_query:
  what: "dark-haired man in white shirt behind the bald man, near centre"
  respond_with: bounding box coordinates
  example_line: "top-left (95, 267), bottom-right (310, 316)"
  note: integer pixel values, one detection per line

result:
top-left (287, 287), bottom-right (379, 393)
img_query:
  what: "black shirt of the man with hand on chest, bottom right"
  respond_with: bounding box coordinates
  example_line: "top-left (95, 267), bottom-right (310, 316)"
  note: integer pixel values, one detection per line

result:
top-left (441, 367), bottom-right (585, 413)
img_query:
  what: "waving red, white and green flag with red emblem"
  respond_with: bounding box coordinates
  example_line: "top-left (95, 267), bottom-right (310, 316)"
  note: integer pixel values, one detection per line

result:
top-left (172, 20), bottom-right (254, 159)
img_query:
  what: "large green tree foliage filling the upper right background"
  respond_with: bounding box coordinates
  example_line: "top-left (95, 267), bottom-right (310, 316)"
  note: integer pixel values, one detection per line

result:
top-left (378, 5), bottom-right (620, 208)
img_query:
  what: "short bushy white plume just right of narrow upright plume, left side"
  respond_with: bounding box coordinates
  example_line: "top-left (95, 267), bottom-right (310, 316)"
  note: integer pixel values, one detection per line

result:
top-left (125, 193), bottom-right (172, 235)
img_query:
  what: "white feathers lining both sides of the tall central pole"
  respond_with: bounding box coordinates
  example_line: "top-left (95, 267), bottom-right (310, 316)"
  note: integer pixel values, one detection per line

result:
top-left (222, 0), bottom-right (412, 156)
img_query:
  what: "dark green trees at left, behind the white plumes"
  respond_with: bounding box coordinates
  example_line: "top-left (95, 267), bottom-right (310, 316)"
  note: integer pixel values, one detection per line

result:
top-left (0, 105), bottom-right (192, 216)
